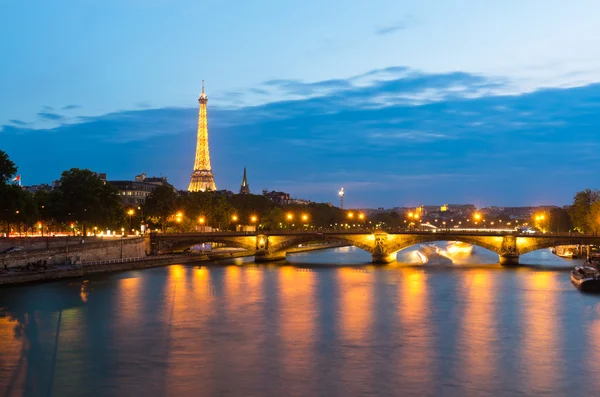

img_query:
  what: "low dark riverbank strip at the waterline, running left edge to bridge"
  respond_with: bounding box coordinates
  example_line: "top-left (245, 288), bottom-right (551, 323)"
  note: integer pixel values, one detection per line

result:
top-left (0, 252), bottom-right (252, 287)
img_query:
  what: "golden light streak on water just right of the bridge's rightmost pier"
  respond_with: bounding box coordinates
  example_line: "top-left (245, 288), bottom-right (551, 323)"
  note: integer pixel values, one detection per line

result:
top-left (519, 271), bottom-right (562, 394)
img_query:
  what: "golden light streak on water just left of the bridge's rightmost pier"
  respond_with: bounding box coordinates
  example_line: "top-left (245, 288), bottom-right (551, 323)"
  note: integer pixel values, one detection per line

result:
top-left (459, 269), bottom-right (498, 387)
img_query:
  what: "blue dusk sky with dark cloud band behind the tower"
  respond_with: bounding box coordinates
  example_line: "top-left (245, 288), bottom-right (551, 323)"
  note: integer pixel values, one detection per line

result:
top-left (0, 0), bottom-right (600, 208)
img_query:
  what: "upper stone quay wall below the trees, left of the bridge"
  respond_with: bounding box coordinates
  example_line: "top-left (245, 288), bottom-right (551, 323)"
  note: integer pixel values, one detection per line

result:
top-left (0, 237), bottom-right (146, 268)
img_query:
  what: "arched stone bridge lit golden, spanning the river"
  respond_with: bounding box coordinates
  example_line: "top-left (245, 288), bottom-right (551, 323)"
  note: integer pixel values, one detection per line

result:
top-left (146, 231), bottom-right (600, 265)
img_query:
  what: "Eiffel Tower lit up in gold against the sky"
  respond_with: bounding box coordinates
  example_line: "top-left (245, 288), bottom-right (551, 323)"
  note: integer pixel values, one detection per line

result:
top-left (188, 80), bottom-right (217, 192)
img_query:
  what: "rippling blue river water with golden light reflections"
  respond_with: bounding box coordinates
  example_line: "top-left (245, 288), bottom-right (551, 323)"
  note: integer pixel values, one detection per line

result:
top-left (0, 243), bottom-right (600, 397)
